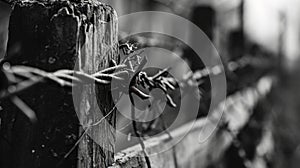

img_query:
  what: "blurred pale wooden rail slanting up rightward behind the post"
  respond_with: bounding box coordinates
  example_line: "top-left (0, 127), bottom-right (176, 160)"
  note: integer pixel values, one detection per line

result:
top-left (110, 76), bottom-right (275, 168)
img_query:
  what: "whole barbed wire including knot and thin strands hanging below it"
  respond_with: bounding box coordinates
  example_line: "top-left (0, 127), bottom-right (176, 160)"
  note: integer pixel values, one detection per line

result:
top-left (0, 42), bottom-right (269, 167)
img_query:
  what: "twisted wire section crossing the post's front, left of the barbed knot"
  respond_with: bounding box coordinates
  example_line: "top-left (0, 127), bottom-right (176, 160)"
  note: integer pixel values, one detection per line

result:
top-left (0, 62), bottom-right (127, 122)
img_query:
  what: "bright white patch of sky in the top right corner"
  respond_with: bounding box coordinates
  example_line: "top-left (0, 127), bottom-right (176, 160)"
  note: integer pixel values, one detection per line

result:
top-left (245, 0), bottom-right (300, 67)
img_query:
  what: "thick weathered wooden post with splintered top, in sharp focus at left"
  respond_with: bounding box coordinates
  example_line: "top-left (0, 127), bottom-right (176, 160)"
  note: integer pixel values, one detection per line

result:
top-left (0, 0), bottom-right (118, 168)
